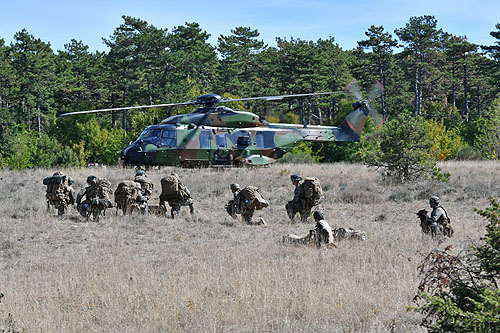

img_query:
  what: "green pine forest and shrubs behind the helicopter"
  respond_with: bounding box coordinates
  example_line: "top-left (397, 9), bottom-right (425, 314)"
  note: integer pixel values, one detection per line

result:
top-left (0, 15), bottom-right (500, 169)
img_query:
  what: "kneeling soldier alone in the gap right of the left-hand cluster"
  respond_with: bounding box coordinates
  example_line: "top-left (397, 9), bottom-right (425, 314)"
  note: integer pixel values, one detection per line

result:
top-left (226, 184), bottom-right (269, 226)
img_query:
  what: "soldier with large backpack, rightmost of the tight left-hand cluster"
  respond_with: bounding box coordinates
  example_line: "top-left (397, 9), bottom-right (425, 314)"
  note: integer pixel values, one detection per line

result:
top-left (160, 173), bottom-right (194, 218)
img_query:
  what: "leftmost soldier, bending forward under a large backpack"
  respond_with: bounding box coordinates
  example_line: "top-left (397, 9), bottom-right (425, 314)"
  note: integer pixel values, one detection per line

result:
top-left (43, 172), bottom-right (75, 215)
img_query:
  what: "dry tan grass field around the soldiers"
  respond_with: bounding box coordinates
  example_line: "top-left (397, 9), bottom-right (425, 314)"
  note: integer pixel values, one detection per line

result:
top-left (0, 162), bottom-right (500, 332)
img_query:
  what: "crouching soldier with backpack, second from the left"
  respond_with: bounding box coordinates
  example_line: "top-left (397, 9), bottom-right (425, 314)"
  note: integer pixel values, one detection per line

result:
top-left (76, 176), bottom-right (113, 221)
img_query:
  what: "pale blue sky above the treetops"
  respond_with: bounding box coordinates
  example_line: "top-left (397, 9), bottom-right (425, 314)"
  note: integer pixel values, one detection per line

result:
top-left (0, 0), bottom-right (500, 52)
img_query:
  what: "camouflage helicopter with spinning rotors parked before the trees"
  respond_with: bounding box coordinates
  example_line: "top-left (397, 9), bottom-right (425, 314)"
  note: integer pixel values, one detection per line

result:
top-left (61, 83), bottom-right (383, 167)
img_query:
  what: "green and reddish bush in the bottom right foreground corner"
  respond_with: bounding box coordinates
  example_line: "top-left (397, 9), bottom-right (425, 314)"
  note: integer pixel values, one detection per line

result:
top-left (410, 198), bottom-right (500, 332)
